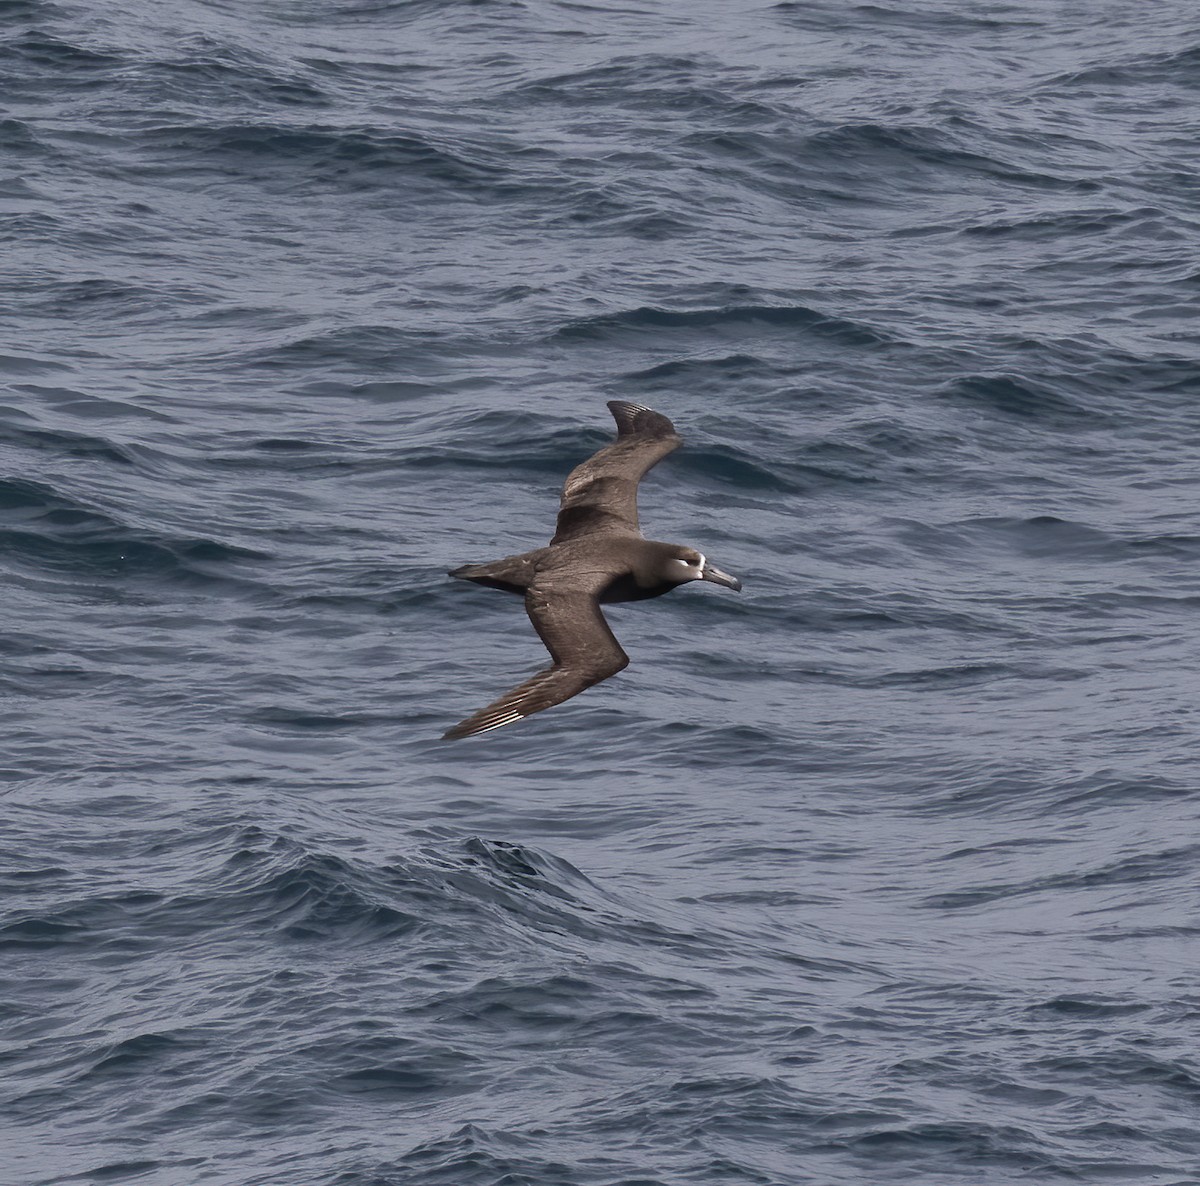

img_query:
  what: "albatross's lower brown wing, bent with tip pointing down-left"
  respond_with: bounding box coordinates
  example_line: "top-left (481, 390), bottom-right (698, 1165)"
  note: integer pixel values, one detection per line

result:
top-left (442, 579), bottom-right (629, 741)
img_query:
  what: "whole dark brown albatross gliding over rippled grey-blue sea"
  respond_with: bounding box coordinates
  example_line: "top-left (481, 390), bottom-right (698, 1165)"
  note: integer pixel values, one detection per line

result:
top-left (443, 400), bottom-right (742, 739)
